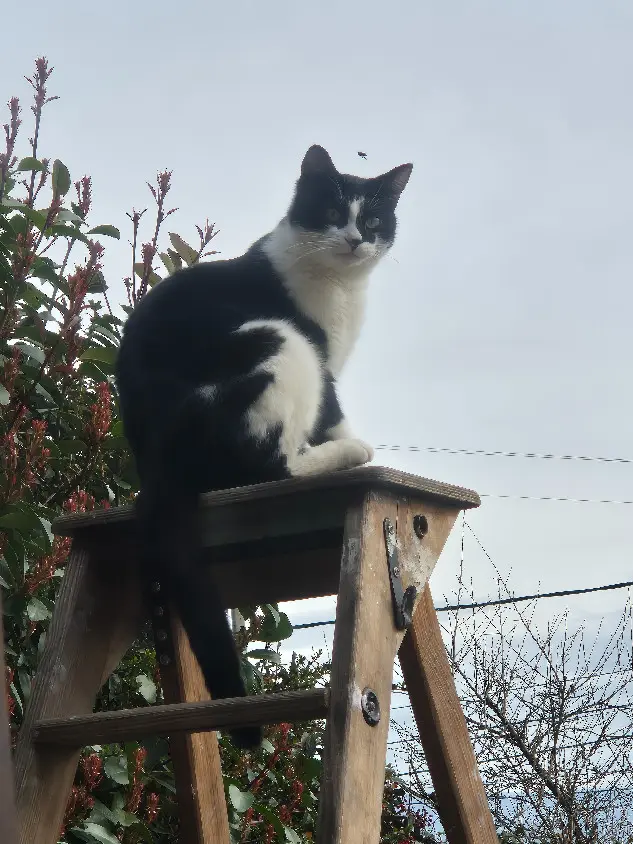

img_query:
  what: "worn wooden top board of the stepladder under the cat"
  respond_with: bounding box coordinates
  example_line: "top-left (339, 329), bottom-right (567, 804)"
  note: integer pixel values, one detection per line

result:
top-left (52, 466), bottom-right (481, 536)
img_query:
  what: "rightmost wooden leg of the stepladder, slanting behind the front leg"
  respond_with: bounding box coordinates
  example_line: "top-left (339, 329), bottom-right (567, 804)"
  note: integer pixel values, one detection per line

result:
top-left (399, 586), bottom-right (498, 844)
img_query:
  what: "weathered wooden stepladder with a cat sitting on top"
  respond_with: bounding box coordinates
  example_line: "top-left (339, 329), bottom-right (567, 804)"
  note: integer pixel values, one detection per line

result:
top-left (8, 467), bottom-right (497, 844)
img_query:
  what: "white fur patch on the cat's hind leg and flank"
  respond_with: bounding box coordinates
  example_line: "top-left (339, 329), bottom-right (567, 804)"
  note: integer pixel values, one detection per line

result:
top-left (238, 320), bottom-right (323, 465)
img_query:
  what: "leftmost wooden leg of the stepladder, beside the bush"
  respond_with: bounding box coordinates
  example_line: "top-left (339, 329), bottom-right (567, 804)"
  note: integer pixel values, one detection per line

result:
top-left (15, 538), bottom-right (142, 844)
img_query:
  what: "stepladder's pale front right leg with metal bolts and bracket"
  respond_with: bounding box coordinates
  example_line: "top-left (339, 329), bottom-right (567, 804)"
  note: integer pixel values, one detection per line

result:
top-left (317, 492), bottom-right (457, 844)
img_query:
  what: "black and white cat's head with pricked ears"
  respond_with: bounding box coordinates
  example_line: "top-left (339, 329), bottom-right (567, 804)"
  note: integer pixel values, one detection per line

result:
top-left (288, 145), bottom-right (413, 270)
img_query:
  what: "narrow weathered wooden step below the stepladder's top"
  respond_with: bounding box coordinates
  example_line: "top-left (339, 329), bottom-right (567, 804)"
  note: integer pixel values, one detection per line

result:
top-left (31, 689), bottom-right (329, 747)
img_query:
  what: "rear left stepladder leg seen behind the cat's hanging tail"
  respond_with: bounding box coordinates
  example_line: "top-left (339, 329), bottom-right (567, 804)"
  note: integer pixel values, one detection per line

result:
top-left (155, 616), bottom-right (230, 844)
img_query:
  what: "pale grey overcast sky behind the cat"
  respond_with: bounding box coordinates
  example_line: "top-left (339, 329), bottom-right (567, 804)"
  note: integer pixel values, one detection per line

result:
top-left (0, 0), bottom-right (633, 640)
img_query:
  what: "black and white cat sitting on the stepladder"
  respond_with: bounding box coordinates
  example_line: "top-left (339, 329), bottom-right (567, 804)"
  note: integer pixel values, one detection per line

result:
top-left (117, 146), bottom-right (412, 747)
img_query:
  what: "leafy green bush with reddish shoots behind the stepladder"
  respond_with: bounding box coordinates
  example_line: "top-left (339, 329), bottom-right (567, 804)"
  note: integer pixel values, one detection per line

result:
top-left (0, 58), bottom-right (424, 844)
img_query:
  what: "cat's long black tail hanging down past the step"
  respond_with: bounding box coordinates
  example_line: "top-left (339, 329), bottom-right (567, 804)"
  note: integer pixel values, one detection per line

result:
top-left (137, 482), bottom-right (262, 748)
